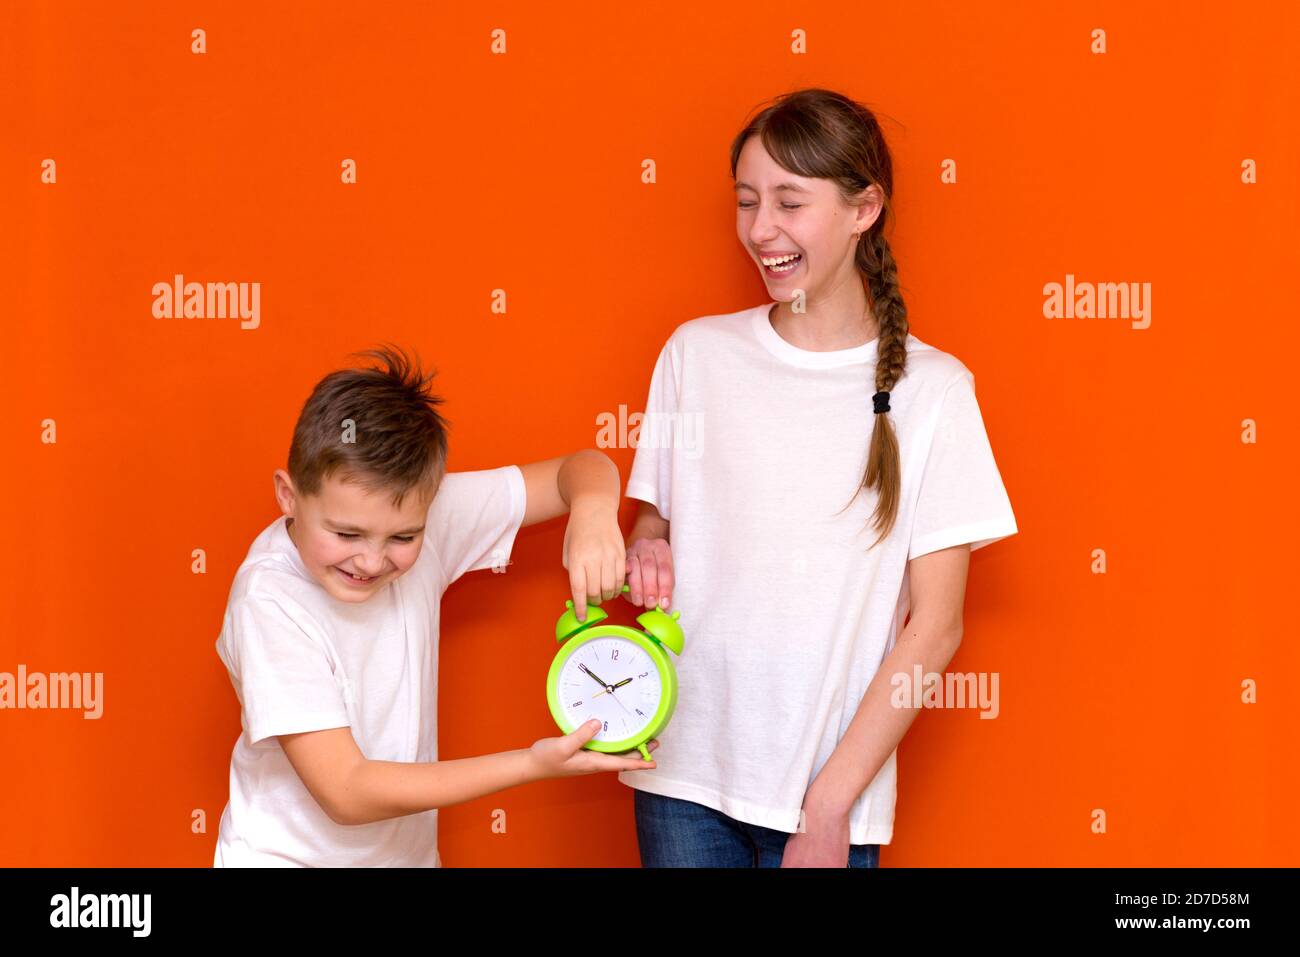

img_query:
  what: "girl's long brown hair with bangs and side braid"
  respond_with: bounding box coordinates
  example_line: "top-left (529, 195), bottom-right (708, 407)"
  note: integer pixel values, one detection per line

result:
top-left (731, 88), bottom-right (907, 545)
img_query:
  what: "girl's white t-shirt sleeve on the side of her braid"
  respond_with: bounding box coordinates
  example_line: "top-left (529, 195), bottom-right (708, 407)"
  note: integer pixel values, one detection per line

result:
top-left (907, 369), bottom-right (1017, 560)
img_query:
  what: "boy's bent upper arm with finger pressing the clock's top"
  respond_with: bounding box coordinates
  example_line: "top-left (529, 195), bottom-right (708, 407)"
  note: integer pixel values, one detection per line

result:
top-left (520, 449), bottom-right (627, 620)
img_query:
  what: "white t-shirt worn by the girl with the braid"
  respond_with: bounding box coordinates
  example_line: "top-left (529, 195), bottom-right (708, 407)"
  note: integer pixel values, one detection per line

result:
top-left (619, 303), bottom-right (1017, 844)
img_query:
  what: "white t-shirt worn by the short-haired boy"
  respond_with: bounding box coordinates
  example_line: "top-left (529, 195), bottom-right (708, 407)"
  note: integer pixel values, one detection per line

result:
top-left (213, 465), bottom-right (525, 867)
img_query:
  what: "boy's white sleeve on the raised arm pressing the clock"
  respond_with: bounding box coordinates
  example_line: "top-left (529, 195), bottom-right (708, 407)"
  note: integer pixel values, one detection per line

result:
top-left (425, 465), bottom-right (528, 585)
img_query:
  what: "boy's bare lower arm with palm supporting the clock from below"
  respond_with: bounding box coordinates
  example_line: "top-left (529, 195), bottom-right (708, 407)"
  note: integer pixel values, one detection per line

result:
top-left (280, 722), bottom-right (659, 824)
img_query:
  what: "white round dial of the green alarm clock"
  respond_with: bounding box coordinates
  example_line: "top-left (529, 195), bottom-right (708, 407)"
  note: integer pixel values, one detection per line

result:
top-left (555, 635), bottom-right (663, 741)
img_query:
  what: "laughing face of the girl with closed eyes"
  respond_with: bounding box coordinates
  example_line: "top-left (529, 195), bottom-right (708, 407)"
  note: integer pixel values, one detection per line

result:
top-left (736, 135), bottom-right (880, 302)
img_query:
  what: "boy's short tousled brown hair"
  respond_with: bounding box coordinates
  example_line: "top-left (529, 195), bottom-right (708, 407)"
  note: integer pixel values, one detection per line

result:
top-left (289, 345), bottom-right (447, 508)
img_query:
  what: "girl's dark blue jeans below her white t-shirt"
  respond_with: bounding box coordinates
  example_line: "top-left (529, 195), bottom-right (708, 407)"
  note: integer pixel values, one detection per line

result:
top-left (632, 788), bottom-right (880, 867)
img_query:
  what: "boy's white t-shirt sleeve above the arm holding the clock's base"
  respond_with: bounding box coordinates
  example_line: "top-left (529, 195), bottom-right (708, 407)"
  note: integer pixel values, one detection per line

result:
top-left (217, 596), bottom-right (351, 744)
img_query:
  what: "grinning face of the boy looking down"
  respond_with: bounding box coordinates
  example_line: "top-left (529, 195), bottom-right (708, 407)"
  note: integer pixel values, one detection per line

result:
top-left (276, 469), bottom-right (433, 602)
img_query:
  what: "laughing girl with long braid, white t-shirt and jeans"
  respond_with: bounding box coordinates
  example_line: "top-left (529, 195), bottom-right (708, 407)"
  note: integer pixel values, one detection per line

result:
top-left (619, 88), bottom-right (1017, 867)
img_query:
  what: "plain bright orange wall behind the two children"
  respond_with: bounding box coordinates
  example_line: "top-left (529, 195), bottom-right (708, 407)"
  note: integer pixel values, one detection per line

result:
top-left (0, 0), bottom-right (1300, 866)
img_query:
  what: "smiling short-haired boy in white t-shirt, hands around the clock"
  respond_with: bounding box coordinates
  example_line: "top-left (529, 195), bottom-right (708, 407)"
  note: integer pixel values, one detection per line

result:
top-left (213, 347), bottom-right (658, 867)
